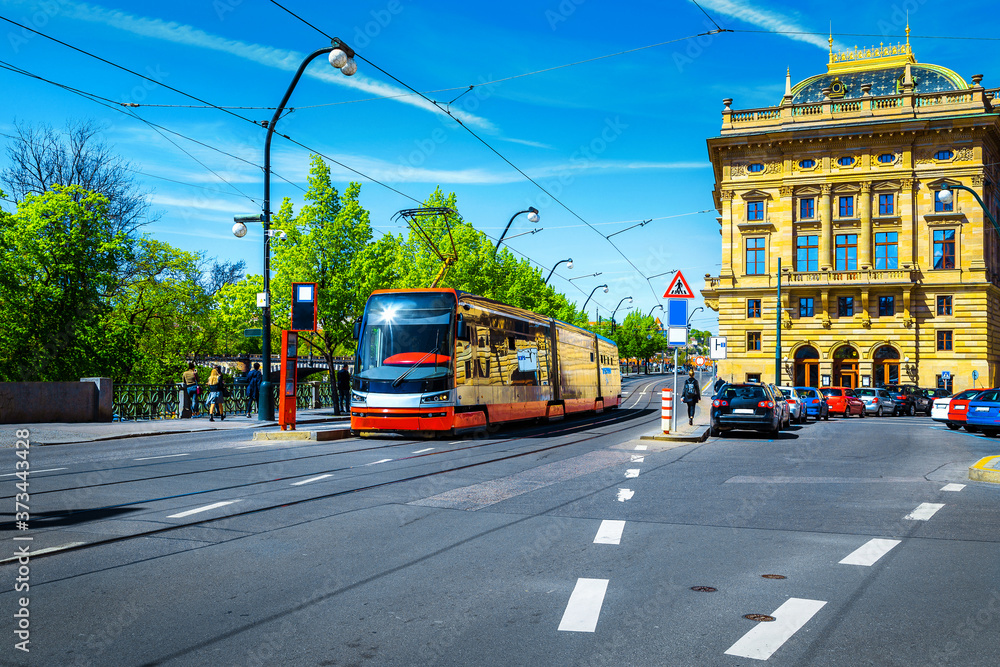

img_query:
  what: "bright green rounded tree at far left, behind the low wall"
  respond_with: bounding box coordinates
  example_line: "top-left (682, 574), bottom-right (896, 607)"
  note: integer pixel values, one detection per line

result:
top-left (0, 186), bottom-right (135, 381)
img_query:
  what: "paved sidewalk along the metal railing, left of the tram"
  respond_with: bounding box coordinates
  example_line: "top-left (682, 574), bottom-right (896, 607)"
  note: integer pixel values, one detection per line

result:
top-left (0, 408), bottom-right (350, 448)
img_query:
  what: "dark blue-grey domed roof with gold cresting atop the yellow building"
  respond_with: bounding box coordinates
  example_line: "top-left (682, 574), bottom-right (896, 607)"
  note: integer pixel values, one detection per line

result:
top-left (785, 26), bottom-right (969, 104)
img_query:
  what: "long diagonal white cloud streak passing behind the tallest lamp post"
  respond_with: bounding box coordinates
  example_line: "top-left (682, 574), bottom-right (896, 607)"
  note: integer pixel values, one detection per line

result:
top-left (56, 2), bottom-right (496, 131)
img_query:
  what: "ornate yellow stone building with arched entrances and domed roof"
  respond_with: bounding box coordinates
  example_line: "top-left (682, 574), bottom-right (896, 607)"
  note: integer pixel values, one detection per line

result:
top-left (702, 28), bottom-right (1000, 391)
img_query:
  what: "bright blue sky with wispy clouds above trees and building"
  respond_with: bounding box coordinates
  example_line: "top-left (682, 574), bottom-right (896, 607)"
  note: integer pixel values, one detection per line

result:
top-left (0, 0), bottom-right (1000, 329)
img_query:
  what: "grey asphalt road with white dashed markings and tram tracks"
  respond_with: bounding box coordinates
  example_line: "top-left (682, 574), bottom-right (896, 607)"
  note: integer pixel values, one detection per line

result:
top-left (0, 376), bottom-right (1000, 666)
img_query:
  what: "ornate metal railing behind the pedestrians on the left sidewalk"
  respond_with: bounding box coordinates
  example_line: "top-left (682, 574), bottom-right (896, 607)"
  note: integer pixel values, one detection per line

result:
top-left (112, 382), bottom-right (335, 421)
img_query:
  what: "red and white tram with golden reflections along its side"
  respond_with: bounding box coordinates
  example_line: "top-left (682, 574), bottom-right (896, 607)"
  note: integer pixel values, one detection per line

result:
top-left (351, 289), bottom-right (621, 435)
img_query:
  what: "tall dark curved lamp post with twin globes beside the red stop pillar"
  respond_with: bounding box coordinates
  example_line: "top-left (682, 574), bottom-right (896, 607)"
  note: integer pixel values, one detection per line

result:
top-left (257, 38), bottom-right (358, 421)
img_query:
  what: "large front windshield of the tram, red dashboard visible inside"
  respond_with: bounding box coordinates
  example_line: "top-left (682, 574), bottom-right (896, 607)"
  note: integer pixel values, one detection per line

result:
top-left (355, 292), bottom-right (455, 382)
